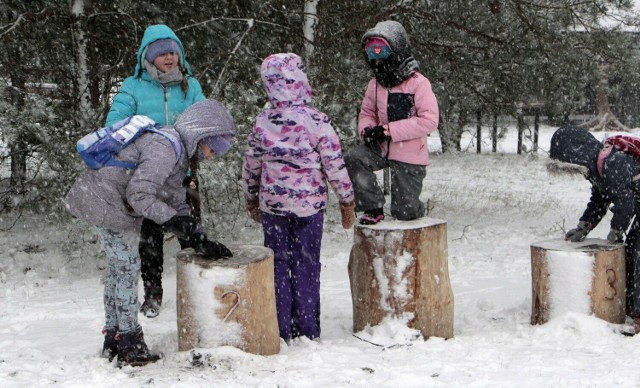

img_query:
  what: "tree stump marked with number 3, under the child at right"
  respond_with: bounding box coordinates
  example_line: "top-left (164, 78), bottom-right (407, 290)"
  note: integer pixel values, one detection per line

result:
top-left (531, 239), bottom-right (625, 325)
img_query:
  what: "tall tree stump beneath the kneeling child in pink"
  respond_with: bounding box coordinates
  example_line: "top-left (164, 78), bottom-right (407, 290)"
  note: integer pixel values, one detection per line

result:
top-left (349, 218), bottom-right (453, 339)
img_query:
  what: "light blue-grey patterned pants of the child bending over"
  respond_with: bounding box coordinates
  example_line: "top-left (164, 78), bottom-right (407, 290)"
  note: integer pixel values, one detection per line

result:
top-left (96, 228), bottom-right (140, 333)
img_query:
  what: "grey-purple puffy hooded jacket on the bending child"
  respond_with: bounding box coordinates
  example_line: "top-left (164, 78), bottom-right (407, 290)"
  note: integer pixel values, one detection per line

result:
top-left (64, 100), bottom-right (235, 232)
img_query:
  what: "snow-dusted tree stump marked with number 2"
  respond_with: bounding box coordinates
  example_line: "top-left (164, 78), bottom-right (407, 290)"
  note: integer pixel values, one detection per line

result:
top-left (176, 245), bottom-right (280, 355)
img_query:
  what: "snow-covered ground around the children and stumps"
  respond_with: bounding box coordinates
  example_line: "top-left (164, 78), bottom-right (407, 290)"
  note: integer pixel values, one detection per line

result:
top-left (0, 123), bottom-right (640, 388)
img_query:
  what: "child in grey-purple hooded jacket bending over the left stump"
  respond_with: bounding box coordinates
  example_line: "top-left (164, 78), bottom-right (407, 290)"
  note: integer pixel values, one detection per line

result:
top-left (65, 100), bottom-right (235, 366)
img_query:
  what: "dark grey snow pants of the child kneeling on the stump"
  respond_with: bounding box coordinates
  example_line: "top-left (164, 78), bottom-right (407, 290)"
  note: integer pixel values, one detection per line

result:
top-left (344, 144), bottom-right (427, 221)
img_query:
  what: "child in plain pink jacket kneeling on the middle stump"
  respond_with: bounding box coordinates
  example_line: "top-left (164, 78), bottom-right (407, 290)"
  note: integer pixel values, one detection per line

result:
top-left (345, 20), bottom-right (439, 224)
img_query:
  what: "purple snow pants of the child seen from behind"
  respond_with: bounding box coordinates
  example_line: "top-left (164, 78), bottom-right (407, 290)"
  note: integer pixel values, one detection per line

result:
top-left (262, 212), bottom-right (324, 341)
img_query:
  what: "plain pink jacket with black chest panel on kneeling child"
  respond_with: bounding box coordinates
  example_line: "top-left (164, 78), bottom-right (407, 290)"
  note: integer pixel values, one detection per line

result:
top-left (358, 72), bottom-right (439, 166)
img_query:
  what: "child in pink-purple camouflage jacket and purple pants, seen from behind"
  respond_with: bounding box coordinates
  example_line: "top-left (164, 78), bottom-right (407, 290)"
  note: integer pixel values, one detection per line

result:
top-left (243, 53), bottom-right (355, 341)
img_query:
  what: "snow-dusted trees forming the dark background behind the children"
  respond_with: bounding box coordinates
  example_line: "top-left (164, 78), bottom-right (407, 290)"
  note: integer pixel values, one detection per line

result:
top-left (0, 0), bottom-right (640, 233)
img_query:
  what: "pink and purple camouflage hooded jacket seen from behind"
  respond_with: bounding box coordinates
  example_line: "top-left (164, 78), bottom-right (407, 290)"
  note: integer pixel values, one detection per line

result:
top-left (243, 54), bottom-right (353, 217)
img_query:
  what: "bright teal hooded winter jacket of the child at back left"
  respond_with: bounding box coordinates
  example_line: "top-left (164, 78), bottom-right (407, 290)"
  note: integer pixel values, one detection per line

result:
top-left (105, 24), bottom-right (205, 126)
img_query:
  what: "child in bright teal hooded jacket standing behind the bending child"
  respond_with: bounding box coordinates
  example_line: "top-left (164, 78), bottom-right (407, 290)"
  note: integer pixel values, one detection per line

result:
top-left (106, 24), bottom-right (205, 318)
